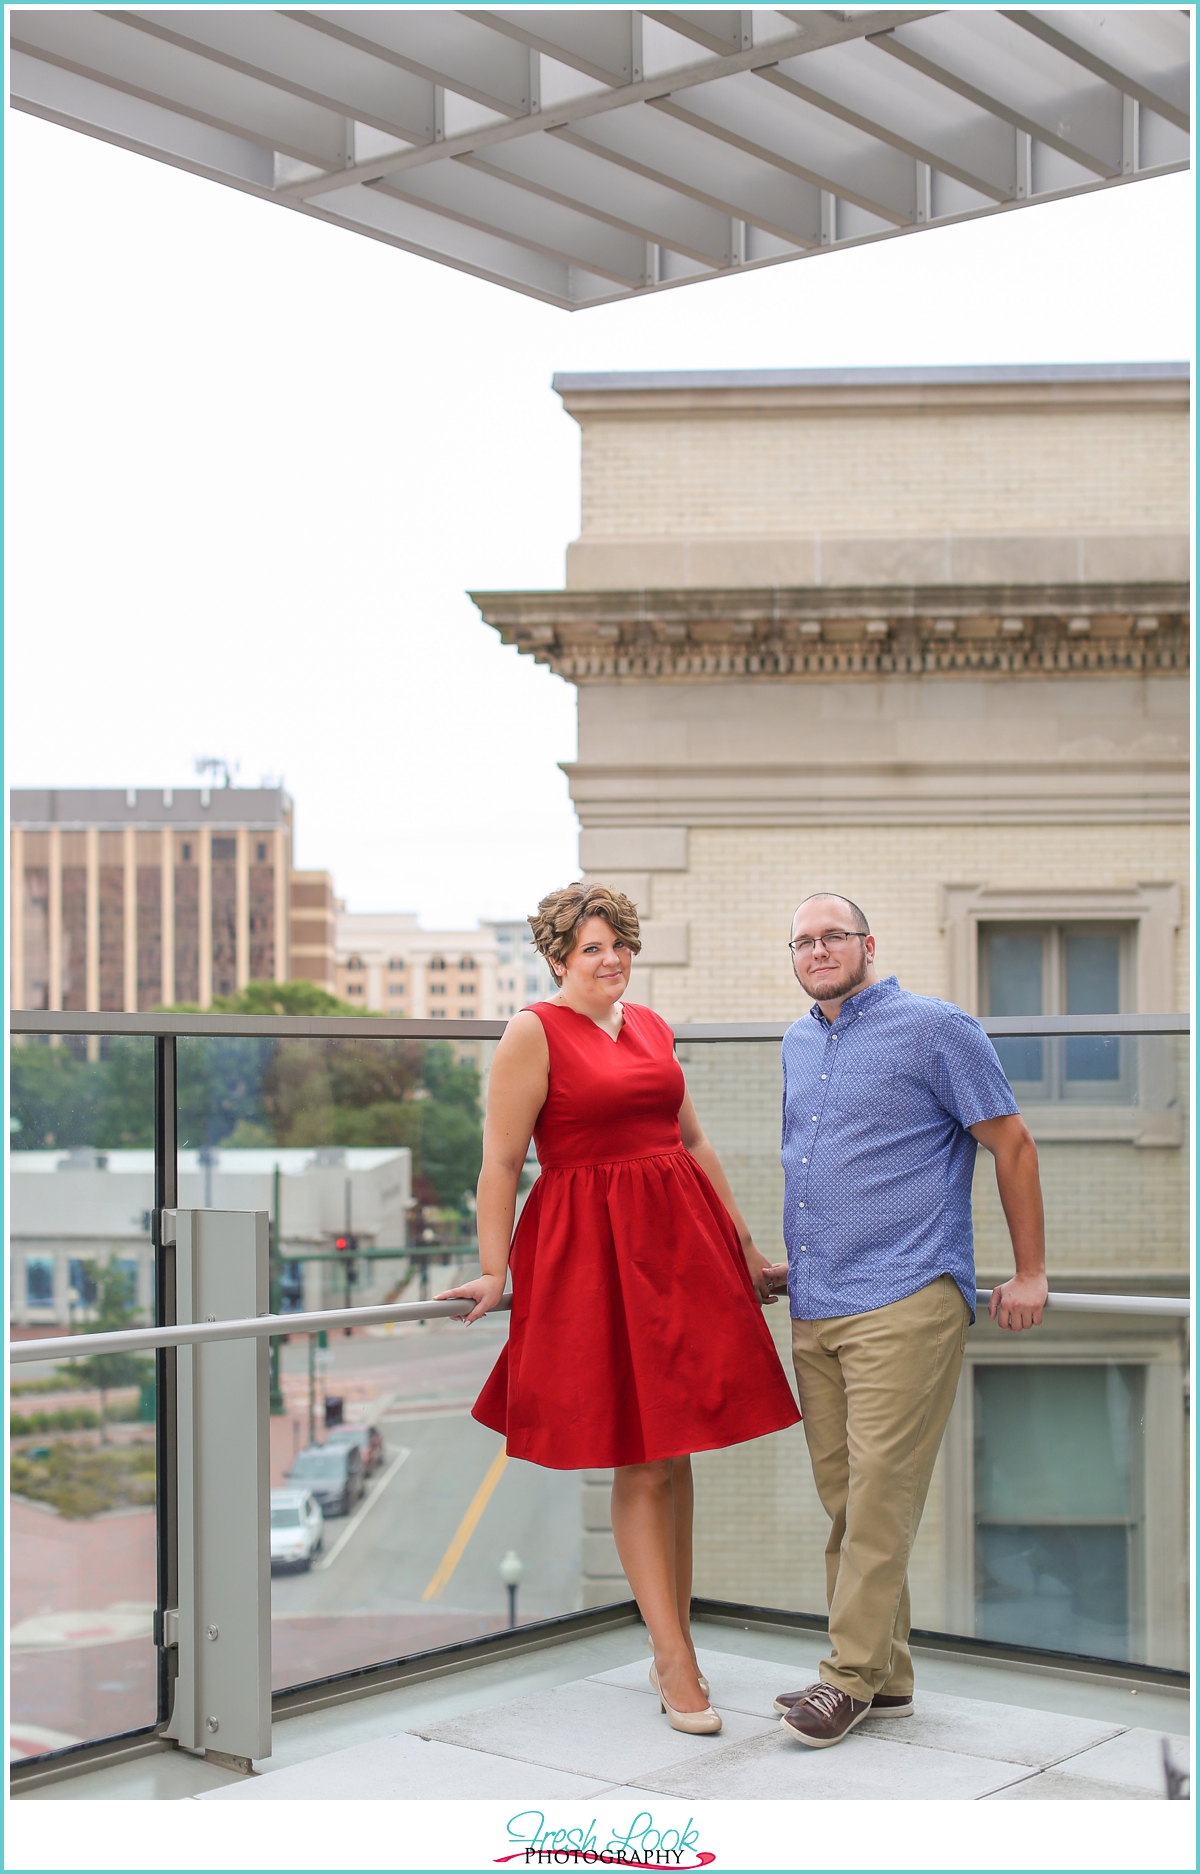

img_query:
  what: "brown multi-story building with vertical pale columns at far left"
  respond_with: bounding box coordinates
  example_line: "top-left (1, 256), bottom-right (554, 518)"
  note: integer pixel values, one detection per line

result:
top-left (11, 787), bottom-right (334, 1010)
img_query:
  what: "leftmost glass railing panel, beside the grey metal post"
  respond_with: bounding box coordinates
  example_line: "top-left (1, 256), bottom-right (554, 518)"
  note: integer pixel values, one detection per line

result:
top-left (9, 1036), bottom-right (158, 1758)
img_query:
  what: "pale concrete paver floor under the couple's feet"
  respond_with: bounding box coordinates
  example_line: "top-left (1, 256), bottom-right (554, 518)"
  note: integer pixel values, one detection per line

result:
top-left (24, 1621), bottom-right (1189, 1801)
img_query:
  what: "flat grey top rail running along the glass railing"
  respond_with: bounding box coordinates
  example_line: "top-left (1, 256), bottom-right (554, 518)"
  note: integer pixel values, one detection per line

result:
top-left (9, 1008), bottom-right (1191, 1042)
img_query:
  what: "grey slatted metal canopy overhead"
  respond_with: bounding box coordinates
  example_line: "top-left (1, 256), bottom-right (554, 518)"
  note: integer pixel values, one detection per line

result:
top-left (9, 6), bottom-right (1191, 309)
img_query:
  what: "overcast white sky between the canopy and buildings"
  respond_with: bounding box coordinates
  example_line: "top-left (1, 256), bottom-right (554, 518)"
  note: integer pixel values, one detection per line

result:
top-left (6, 112), bottom-right (1194, 928)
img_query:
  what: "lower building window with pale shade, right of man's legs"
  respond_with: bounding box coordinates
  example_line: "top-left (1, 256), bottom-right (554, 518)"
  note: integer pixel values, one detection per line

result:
top-left (973, 1361), bottom-right (1146, 1658)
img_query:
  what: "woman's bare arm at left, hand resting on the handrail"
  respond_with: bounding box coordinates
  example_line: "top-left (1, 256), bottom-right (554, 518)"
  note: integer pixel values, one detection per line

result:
top-left (437, 1008), bottom-right (549, 1323)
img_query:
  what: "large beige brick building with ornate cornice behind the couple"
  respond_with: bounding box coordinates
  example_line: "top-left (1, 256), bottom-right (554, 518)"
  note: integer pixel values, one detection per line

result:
top-left (476, 365), bottom-right (1191, 1662)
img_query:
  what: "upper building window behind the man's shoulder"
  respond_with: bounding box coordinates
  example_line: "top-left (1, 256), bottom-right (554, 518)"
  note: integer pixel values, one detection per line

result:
top-left (979, 924), bottom-right (1134, 1102)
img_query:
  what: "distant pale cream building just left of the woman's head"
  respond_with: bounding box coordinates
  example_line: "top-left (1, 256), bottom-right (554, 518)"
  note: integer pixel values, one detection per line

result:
top-left (336, 909), bottom-right (499, 1021)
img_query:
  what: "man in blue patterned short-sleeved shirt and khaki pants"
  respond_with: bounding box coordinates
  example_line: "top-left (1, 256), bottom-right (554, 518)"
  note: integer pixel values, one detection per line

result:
top-left (773, 892), bottom-right (1046, 1748)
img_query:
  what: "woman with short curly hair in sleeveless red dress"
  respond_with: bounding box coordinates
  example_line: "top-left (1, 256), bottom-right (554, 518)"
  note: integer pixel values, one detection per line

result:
top-left (439, 885), bottom-right (801, 1733)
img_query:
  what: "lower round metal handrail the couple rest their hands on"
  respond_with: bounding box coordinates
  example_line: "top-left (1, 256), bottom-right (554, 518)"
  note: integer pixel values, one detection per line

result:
top-left (8, 1289), bottom-right (1193, 1366)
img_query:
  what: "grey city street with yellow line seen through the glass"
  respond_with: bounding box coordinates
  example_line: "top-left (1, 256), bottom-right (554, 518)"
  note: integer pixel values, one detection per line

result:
top-left (272, 1319), bottom-right (581, 1685)
